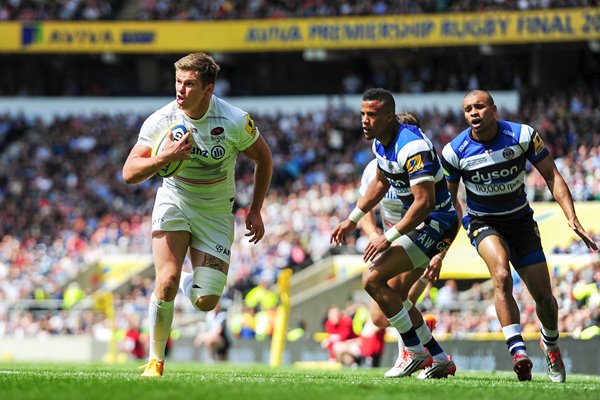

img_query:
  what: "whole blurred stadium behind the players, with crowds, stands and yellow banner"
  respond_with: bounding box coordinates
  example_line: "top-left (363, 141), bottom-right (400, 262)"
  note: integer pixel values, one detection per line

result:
top-left (0, 0), bottom-right (600, 373)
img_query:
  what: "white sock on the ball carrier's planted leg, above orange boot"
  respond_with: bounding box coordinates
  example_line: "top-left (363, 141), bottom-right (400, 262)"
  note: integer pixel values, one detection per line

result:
top-left (148, 292), bottom-right (175, 360)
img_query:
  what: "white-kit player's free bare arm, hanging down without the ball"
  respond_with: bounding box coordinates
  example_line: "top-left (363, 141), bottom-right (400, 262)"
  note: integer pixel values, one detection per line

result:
top-left (243, 136), bottom-right (273, 243)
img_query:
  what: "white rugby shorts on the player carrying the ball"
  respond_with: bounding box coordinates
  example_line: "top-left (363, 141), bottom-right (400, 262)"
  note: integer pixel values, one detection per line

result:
top-left (152, 187), bottom-right (235, 265)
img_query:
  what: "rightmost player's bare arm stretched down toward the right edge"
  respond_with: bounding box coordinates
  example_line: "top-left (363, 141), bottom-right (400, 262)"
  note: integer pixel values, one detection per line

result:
top-left (535, 155), bottom-right (598, 251)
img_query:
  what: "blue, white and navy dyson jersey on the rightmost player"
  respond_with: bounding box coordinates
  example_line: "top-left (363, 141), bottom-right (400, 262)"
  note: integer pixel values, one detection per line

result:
top-left (442, 121), bottom-right (549, 216)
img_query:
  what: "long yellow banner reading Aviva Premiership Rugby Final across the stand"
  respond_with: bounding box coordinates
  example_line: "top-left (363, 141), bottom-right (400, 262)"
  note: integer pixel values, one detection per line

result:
top-left (0, 8), bottom-right (600, 53)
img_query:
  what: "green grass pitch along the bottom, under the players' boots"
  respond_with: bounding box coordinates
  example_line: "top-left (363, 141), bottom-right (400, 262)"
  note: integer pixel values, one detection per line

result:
top-left (0, 362), bottom-right (600, 400)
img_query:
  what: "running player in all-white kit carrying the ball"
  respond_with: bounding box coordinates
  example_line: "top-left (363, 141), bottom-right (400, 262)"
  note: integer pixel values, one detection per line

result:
top-left (123, 53), bottom-right (273, 377)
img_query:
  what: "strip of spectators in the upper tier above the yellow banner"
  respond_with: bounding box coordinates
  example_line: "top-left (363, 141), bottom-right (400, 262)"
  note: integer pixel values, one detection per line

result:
top-left (0, 0), bottom-right (599, 21)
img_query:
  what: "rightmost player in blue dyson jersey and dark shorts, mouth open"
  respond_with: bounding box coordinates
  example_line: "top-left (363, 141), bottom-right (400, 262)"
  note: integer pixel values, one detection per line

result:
top-left (441, 90), bottom-right (598, 382)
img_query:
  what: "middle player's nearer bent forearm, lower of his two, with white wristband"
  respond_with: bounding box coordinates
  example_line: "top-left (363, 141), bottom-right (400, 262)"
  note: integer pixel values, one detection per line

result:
top-left (363, 180), bottom-right (435, 262)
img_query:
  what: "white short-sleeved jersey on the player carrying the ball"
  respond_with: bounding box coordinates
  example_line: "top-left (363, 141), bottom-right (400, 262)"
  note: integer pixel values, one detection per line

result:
top-left (137, 95), bottom-right (260, 214)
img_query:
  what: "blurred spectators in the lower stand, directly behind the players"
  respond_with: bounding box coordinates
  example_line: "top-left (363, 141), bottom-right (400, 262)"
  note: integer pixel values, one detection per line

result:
top-left (0, 87), bottom-right (600, 344)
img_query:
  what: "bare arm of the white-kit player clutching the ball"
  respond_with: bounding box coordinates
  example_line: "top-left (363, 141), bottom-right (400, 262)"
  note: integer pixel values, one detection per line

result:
top-left (123, 132), bottom-right (193, 185)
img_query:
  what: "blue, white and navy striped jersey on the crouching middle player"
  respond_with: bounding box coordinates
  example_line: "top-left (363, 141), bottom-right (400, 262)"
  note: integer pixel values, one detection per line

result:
top-left (373, 124), bottom-right (456, 222)
